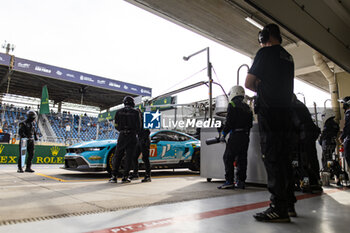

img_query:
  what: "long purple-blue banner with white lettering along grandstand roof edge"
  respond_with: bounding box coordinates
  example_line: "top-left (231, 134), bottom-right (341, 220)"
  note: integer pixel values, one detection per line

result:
top-left (13, 58), bottom-right (152, 96)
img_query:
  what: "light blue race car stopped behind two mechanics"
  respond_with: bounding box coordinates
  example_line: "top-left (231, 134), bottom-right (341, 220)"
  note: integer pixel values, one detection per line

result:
top-left (63, 130), bottom-right (200, 173)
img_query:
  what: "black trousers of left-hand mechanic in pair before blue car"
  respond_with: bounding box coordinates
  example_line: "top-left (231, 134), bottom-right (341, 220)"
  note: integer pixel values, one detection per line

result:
top-left (112, 133), bottom-right (137, 177)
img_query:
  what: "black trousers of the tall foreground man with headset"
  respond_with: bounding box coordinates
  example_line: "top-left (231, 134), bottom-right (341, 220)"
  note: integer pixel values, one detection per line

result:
top-left (258, 108), bottom-right (296, 212)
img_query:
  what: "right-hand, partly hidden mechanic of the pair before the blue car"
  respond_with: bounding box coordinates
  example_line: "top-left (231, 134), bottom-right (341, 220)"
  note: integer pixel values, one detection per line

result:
top-left (129, 110), bottom-right (152, 182)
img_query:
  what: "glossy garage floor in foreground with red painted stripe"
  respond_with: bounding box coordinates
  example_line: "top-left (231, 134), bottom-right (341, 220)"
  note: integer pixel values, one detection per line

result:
top-left (0, 186), bottom-right (350, 233)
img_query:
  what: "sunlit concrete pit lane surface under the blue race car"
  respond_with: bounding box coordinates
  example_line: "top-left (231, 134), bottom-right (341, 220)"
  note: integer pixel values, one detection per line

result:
top-left (0, 165), bottom-right (266, 225)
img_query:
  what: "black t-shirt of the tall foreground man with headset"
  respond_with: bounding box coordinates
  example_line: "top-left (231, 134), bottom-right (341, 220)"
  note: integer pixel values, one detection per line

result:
top-left (248, 45), bottom-right (294, 108)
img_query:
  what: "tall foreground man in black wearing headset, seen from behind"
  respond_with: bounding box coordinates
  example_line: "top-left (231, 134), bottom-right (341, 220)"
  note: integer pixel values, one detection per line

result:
top-left (245, 24), bottom-right (296, 222)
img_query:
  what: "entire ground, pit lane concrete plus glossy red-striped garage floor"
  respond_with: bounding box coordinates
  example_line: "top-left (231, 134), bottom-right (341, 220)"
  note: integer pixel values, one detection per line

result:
top-left (0, 167), bottom-right (350, 233)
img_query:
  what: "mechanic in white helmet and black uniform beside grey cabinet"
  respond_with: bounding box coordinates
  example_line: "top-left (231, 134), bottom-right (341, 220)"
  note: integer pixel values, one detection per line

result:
top-left (218, 86), bottom-right (253, 189)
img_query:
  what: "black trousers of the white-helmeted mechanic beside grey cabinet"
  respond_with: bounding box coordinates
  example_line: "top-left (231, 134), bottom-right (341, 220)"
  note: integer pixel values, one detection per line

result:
top-left (224, 132), bottom-right (249, 182)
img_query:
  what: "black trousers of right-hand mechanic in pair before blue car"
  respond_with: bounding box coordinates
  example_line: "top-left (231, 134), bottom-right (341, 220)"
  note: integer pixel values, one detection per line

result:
top-left (133, 139), bottom-right (151, 176)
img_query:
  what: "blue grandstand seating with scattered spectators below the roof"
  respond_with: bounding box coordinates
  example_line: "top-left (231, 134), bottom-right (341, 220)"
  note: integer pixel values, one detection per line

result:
top-left (0, 106), bottom-right (117, 143)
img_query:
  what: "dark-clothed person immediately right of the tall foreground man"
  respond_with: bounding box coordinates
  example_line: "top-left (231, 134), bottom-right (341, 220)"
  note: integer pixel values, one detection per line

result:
top-left (292, 95), bottom-right (323, 193)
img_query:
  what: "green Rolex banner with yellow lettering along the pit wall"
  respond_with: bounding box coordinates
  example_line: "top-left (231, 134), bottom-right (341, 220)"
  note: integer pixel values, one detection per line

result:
top-left (0, 144), bottom-right (66, 164)
